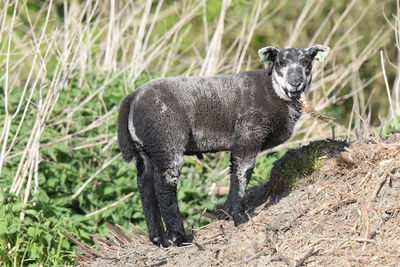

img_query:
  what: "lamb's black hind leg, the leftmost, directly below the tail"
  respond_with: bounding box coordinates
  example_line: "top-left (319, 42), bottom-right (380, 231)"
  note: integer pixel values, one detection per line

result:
top-left (136, 153), bottom-right (168, 247)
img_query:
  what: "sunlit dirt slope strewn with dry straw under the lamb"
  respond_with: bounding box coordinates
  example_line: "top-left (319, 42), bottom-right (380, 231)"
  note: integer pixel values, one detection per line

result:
top-left (69, 140), bottom-right (400, 266)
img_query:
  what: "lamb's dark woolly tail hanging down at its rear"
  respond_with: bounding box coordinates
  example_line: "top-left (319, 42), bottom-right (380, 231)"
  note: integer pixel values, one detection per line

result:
top-left (118, 94), bottom-right (136, 162)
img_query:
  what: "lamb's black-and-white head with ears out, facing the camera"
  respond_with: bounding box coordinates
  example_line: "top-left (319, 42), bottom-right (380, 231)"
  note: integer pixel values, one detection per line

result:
top-left (258, 45), bottom-right (330, 101)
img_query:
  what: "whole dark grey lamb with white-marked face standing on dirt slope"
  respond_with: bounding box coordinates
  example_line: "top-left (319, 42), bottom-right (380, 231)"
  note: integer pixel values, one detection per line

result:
top-left (118, 45), bottom-right (329, 247)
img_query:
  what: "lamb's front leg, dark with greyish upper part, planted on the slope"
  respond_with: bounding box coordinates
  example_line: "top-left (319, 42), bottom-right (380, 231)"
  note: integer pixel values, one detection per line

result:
top-left (223, 152), bottom-right (256, 226)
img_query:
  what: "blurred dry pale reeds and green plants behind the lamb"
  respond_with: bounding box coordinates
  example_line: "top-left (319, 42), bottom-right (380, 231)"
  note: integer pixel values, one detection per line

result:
top-left (0, 0), bottom-right (400, 266)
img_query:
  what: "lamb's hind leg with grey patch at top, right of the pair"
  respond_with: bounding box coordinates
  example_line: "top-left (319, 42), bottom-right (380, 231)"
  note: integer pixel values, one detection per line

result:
top-left (154, 156), bottom-right (190, 245)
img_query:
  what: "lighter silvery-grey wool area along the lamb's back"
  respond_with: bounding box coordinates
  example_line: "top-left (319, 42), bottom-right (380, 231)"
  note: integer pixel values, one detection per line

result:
top-left (136, 70), bottom-right (265, 126)
